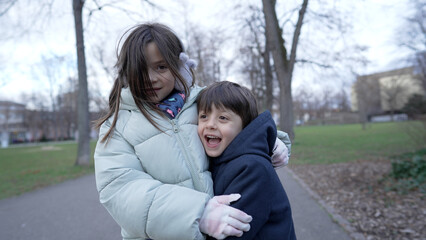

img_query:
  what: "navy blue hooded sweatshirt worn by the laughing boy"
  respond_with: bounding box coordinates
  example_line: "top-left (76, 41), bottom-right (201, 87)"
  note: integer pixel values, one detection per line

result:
top-left (210, 111), bottom-right (296, 240)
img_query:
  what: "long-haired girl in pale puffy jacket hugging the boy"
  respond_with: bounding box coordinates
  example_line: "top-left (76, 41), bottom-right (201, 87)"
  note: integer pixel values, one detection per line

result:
top-left (95, 23), bottom-right (286, 239)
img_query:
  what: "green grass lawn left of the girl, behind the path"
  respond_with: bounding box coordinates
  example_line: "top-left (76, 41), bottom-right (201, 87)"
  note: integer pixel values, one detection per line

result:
top-left (0, 142), bottom-right (95, 199)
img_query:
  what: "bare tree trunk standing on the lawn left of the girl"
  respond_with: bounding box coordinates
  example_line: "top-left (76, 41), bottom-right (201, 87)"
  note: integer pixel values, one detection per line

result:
top-left (73, 0), bottom-right (90, 166)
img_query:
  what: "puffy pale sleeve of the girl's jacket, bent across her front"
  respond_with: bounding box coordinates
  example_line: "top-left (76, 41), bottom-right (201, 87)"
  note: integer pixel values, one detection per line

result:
top-left (95, 117), bottom-right (210, 239)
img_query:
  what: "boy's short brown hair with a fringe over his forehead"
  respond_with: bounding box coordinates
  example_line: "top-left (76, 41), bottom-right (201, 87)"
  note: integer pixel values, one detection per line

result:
top-left (197, 81), bottom-right (259, 128)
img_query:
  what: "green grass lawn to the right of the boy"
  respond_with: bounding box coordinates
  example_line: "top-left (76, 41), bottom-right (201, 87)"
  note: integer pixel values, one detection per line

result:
top-left (290, 122), bottom-right (425, 164)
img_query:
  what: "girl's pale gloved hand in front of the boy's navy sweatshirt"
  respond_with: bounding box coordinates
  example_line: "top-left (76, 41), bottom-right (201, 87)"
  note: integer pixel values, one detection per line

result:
top-left (200, 194), bottom-right (253, 239)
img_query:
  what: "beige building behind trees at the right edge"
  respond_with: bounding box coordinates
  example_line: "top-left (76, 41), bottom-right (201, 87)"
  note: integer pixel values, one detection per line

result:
top-left (351, 67), bottom-right (424, 117)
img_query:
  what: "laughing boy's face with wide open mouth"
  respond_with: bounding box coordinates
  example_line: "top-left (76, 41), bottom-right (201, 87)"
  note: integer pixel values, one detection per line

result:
top-left (198, 106), bottom-right (243, 157)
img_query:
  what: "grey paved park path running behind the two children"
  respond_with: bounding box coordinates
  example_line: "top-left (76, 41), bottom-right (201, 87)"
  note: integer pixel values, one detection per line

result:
top-left (0, 168), bottom-right (352, 240)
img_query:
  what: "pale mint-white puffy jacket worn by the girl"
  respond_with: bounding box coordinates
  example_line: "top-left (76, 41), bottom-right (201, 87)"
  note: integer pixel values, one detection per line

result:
top-left (95, 87), bottom-right (213, 240)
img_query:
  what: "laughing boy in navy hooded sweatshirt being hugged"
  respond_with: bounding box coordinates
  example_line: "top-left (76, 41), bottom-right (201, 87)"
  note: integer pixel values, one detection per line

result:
top-left (197, 81), bottom-right (296, 240)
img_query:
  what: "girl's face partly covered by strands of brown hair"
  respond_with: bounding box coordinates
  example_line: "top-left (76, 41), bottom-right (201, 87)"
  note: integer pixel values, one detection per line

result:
top-left (145, 42), bottom-right (175, 102)
